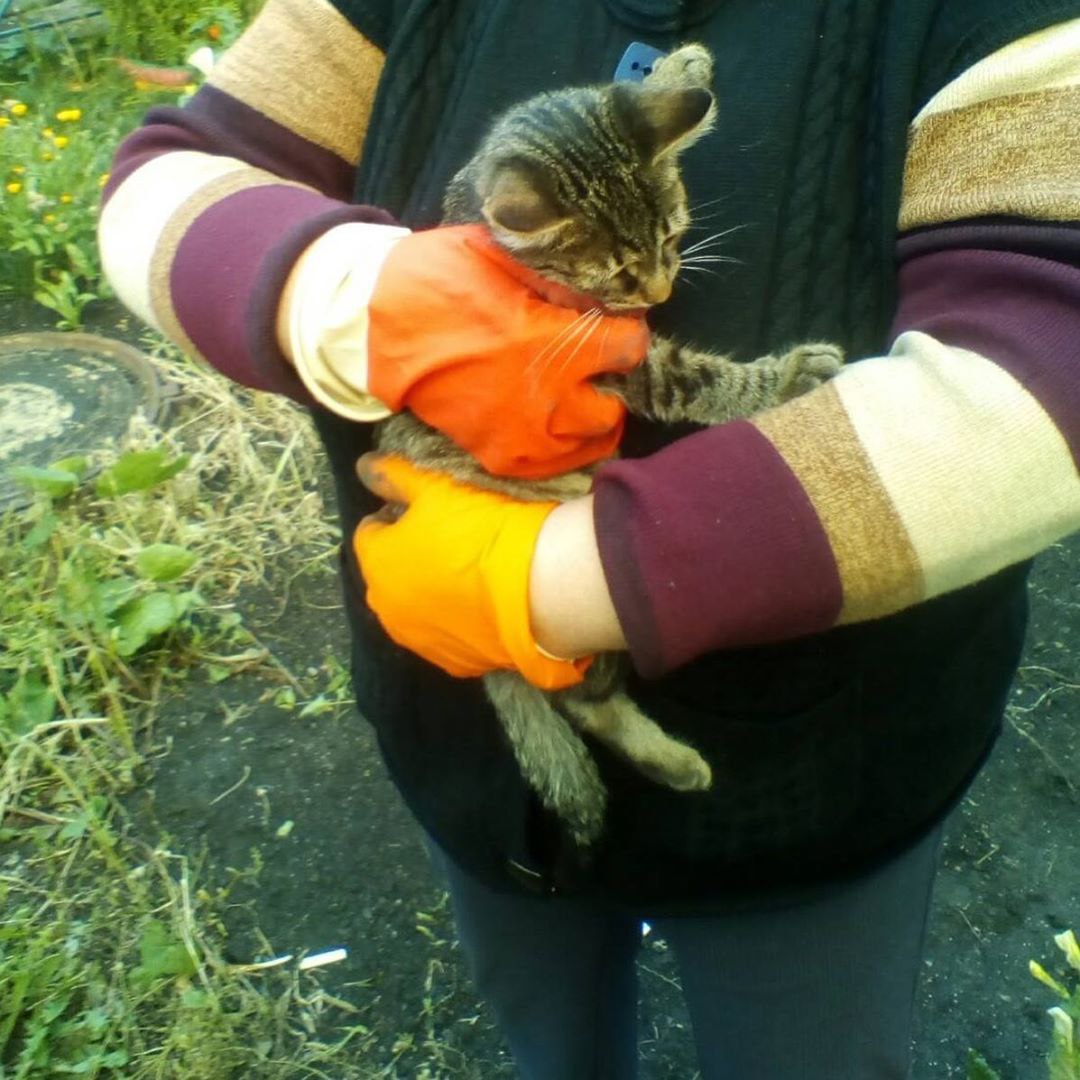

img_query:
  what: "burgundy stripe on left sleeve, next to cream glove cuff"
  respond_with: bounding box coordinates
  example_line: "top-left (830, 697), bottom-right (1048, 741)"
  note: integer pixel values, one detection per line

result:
top-left (170, 185), bottom-right (391, 402)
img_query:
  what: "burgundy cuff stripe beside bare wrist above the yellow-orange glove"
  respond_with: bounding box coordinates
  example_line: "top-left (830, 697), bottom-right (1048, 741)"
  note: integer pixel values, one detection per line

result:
top-left (594, 421), bottom-right (842, 676)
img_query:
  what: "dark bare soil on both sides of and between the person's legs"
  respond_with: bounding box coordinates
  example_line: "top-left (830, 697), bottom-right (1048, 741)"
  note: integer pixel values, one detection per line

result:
top-left (8, 300), bottom-right (1080, 1080)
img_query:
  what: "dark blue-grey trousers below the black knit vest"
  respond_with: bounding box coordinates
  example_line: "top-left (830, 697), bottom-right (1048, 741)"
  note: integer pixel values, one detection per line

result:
top-left (425, 828), bottom-right (942, 1080)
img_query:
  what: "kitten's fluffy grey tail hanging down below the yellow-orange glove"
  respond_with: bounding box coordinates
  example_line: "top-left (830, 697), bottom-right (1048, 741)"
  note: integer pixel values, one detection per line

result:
top-left (484, 672), bottom-right (607, 847)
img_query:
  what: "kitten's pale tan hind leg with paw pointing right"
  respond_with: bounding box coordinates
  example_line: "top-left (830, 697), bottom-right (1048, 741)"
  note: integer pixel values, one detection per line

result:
top-left (557, 690), bottom-right (713, 792)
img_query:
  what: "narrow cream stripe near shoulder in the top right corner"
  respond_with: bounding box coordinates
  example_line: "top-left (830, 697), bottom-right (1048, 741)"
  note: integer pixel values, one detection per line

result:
top-left (915, 18), bottom-right (1080, 124)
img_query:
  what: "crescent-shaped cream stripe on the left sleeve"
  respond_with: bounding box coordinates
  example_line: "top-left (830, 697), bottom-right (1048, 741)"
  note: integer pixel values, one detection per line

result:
top-left (98, 150), bottom-right (257, 329)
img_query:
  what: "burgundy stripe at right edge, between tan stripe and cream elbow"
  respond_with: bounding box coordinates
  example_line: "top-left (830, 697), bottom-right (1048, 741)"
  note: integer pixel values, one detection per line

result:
top-left (894, 226), bottom-right (1080, 465)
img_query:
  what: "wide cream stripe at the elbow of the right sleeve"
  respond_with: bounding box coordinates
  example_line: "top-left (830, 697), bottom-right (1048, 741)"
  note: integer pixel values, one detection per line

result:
top-left (832, 330), bottom-right (1080, 597)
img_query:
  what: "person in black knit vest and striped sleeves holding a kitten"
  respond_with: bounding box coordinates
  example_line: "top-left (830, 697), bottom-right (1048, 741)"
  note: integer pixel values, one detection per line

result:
top-left (100, 0), bottom-right (1080, 1080)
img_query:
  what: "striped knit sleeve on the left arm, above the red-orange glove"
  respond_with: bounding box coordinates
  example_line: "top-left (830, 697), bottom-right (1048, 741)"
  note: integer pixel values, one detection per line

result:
top-left (98, 0), bottom-right (391, 402)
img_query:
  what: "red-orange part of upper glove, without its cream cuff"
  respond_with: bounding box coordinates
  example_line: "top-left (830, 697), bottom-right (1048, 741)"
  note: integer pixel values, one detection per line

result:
top-left (367, 226), bottom-right (648, 477)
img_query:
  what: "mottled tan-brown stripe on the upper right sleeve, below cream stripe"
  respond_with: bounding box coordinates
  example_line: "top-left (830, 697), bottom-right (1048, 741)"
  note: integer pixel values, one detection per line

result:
top-left (900, 86), bottom-right (1080, 229)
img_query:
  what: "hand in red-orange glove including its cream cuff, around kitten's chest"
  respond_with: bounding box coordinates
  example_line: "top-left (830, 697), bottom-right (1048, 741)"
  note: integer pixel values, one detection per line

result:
top-left (281, 224), bottom-right (648, 477)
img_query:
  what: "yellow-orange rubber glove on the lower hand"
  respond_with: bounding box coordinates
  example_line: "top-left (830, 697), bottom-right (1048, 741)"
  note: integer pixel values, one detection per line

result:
top-left (353, 457), bottom-right (592, 690)
